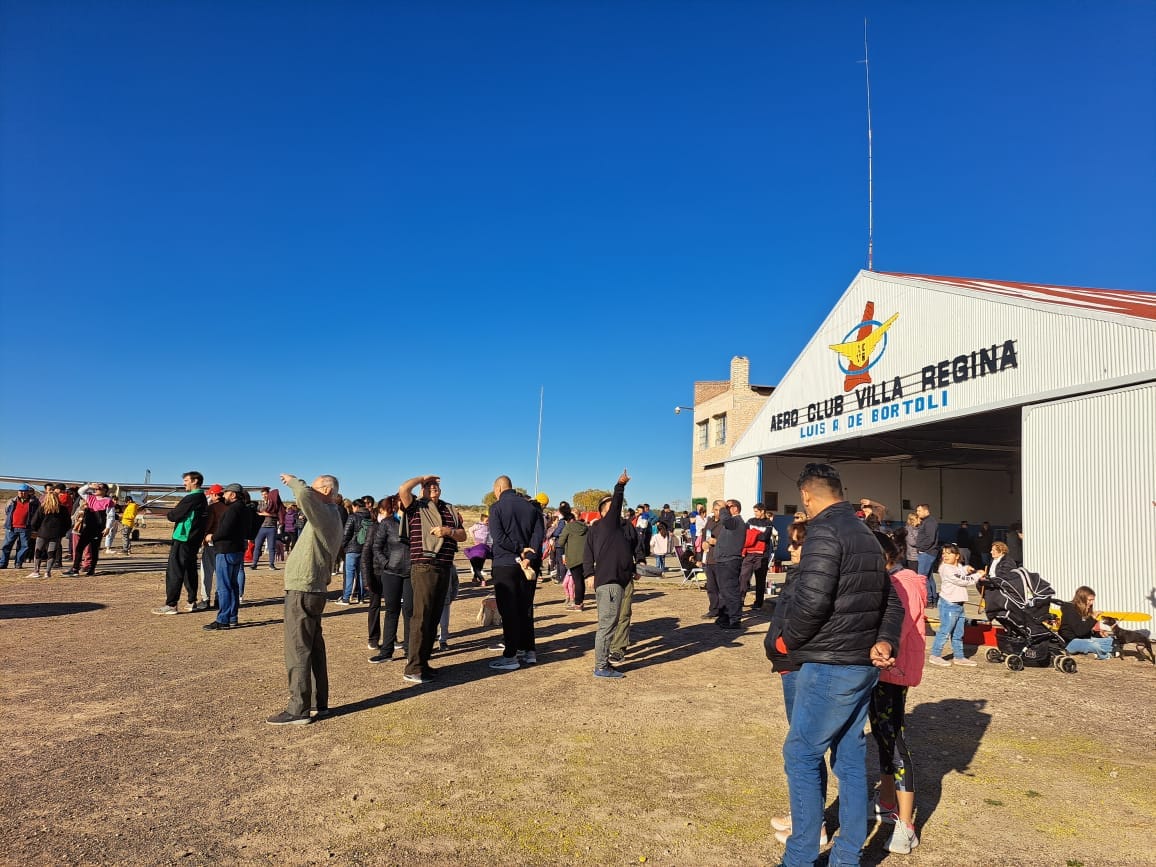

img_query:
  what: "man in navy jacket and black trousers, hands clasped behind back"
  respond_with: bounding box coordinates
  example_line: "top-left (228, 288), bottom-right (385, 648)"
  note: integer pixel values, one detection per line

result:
top-left (490, 475), bottom-right (546, 672)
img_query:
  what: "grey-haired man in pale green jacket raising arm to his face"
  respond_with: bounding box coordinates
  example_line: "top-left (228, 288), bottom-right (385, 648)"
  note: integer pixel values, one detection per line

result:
top-left (265, 473), bottom-right (341, 726)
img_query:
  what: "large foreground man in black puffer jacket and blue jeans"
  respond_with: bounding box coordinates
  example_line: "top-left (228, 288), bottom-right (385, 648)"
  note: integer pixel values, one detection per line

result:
top-left (778, 464), bottom-right (903, 867)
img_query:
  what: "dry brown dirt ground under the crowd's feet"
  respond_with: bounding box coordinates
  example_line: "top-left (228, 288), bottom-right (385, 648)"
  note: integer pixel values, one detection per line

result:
top-left (0, 536), bottom-right (1156, 867)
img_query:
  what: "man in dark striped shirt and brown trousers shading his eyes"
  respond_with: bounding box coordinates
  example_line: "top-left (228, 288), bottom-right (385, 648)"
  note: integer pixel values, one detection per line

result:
top-left (398, 475), bottom-right (466, 683)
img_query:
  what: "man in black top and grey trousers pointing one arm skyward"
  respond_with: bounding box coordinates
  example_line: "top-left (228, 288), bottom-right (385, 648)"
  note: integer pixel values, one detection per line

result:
top-left (583, 469), bottom-right (635, 677)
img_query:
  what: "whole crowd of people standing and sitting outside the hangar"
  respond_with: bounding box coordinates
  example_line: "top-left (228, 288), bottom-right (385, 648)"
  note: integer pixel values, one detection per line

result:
top-left (0, 464), bottom-right (1132, 865)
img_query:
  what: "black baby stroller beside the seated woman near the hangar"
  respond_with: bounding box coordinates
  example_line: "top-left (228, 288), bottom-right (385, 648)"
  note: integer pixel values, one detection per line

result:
top-left (984, 568), bottom-right (1076, 674)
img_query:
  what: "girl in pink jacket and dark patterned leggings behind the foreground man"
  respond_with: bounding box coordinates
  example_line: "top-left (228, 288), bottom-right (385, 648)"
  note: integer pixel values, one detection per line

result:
top-left (867, 533), bottom-right (927, 854)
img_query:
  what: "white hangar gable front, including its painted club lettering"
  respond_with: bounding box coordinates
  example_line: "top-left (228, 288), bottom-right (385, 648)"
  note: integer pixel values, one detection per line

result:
top-left (732, 272), bottom-right (1156, 459)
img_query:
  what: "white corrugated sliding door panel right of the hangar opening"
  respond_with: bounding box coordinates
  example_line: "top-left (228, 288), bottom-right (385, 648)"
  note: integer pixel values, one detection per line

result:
top-left (1023, 383), bottom-right (1156, 629)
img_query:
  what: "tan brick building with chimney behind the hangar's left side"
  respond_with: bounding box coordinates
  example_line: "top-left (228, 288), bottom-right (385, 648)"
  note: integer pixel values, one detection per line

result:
top-left (690, 355), bottom-right (775, 511)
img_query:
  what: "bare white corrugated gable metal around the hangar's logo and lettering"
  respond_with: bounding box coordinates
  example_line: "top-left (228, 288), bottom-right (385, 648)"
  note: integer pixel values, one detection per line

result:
top-left (732, 272), bottom-right (1156, 458)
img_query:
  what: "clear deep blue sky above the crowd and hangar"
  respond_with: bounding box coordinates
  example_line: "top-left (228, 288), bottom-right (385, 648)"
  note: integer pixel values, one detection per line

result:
top-left (0, 0), bottom-right (1156, 503)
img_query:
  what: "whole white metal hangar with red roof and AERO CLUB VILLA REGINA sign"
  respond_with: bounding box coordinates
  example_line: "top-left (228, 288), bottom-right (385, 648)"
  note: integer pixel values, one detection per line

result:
top-left (724, 272), bottom-right (1156, 613)
